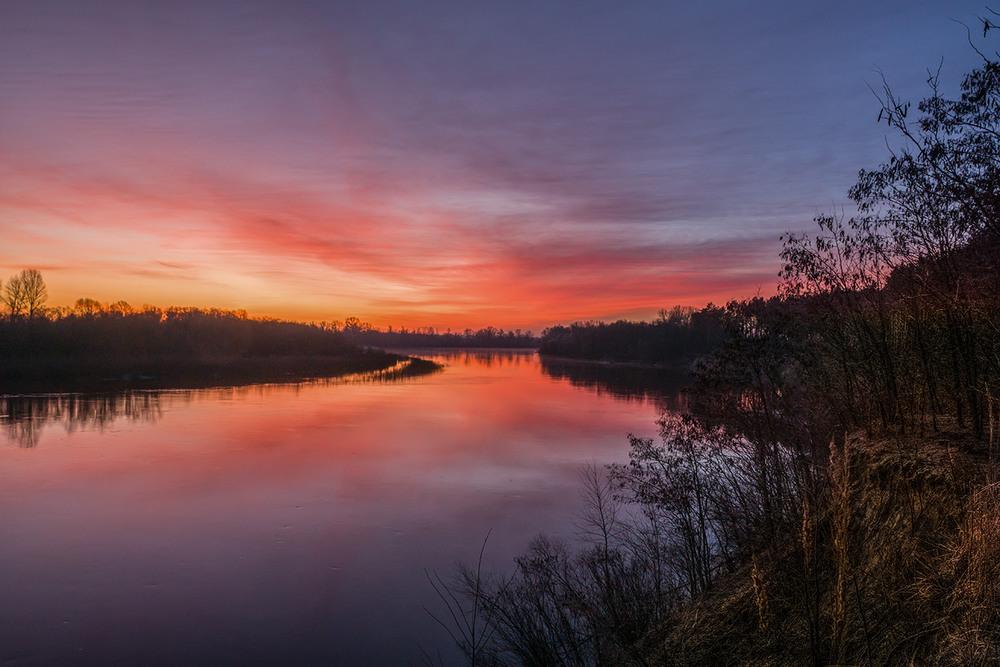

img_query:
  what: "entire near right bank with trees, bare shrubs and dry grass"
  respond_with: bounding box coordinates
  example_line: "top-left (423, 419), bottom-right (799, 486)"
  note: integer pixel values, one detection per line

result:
top-left (431, 19), bottom-right (1000, 665)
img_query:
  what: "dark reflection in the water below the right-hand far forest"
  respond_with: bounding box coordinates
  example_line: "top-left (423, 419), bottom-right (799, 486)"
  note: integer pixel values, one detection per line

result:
top-left (541, 357), bottom-right (690, 411)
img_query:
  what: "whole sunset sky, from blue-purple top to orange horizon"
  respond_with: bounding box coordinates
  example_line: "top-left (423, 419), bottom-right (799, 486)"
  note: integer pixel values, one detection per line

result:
top-left (0, 0), bottom-right (996, 332)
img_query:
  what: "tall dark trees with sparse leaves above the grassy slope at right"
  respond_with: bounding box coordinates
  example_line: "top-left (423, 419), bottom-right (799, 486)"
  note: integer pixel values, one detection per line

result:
top-left (782, 36), bottom-right (1000, 436)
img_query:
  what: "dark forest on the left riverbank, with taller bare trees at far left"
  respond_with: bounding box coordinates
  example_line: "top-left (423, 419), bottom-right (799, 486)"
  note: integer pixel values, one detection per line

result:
top-left (0, 280), bottom-right (410, 390)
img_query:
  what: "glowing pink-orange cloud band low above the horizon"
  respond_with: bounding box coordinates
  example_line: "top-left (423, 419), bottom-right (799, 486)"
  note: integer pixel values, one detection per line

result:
top-left (4, 145), bottom-right (777, 329)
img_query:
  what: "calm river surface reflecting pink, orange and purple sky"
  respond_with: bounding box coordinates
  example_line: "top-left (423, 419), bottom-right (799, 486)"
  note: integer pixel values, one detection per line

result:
top-left (0, 352), bottom-right (674, 665)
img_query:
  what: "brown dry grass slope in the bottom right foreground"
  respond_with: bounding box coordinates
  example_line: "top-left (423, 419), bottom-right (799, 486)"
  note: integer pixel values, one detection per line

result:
top-left (652, 437), bottom-right (1000, 665)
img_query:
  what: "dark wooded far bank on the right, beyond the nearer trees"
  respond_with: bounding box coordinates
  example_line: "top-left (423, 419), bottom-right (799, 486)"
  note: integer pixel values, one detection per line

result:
top-left (538, 304), bottom-right (725, 367)
